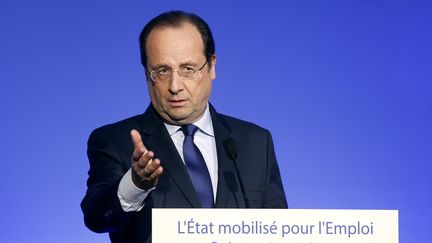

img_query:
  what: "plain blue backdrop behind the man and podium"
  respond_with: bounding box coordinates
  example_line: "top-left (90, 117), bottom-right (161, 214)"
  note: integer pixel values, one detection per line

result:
top-left (0, 0), bottom-right (432, 243)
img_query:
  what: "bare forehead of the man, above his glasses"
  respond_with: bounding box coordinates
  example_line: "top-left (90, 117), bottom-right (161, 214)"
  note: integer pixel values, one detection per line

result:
top-left (146, 22), bottom-right (204, 66)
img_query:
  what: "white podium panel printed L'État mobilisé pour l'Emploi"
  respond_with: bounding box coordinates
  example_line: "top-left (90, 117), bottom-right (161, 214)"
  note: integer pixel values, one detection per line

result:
top-left (152, 209), bottom-right (398, 243)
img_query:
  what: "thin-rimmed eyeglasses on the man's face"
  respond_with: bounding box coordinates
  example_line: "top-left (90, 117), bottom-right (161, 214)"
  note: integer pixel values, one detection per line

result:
top-left (150, 60), bottom-right (207, 82)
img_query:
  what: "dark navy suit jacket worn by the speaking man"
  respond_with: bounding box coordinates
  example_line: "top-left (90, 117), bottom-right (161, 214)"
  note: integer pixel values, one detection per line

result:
top-left (81, 105), bottom-right (287, 243)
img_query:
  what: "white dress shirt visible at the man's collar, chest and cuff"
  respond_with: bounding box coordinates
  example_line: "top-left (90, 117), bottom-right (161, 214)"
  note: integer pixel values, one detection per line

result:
top-left (117, 104), bottom-right (218, 212)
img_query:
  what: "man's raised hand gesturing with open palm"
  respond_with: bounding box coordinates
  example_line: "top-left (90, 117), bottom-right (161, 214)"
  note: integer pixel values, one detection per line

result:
top-left (130, 129), bottom-right (163, 190)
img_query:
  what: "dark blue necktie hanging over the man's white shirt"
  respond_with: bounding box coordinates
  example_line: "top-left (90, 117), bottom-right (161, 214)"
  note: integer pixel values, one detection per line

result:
top-left (181, 124), bottom-right (213, 208)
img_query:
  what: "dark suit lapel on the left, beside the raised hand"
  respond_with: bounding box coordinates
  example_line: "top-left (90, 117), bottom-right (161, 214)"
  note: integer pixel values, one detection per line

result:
top-left (138, 105), bottom-right (201, 207)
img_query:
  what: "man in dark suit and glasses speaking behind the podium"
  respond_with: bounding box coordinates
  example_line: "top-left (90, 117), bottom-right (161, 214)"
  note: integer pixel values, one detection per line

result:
top-left (81, 11), bottom-right (287, 242)
